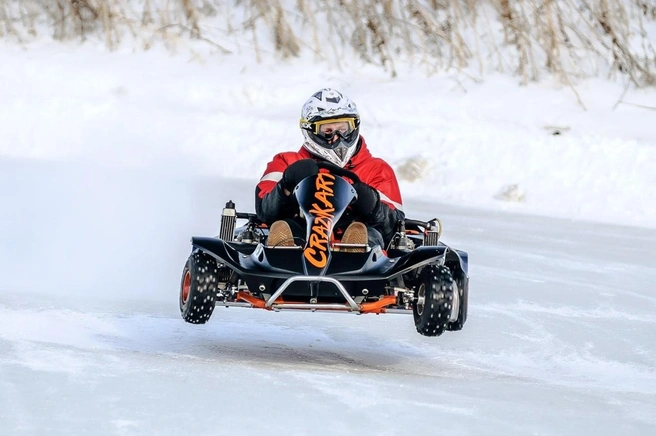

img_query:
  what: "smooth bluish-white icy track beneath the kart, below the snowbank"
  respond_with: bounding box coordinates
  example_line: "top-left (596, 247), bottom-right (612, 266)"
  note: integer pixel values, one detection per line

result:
top-left (0, 160), bottom-right (656, 436)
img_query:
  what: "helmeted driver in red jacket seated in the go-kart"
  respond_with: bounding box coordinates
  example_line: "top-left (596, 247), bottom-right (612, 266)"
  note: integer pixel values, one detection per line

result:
top-left (255, 88), bottom-right (405, 251)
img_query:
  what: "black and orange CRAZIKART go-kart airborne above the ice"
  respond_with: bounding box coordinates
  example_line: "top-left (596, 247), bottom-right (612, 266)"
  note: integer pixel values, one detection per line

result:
top-left (180, 162), bottom-right (469, 336)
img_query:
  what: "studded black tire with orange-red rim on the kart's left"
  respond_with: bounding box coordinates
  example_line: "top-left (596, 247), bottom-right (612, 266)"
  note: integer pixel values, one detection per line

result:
top-left (180, 251), bottom-right (219, 324)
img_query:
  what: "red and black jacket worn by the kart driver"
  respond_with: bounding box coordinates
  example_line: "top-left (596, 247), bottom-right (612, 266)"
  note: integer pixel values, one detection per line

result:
top-left (255, 136), bottom-right (405, 248)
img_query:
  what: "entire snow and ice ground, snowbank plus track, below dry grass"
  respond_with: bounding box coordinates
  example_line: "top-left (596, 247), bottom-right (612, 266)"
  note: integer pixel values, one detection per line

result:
top-left (0, 39), bottom-right (656, 435)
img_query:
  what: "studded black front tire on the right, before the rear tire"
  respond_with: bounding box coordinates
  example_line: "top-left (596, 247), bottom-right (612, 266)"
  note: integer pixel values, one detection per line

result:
top-left (412, 265), bottom-right (458, 336)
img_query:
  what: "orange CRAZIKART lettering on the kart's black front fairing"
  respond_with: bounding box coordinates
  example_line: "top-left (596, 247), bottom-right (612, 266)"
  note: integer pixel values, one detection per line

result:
top-left (303, 173), bottom-right (335, 268)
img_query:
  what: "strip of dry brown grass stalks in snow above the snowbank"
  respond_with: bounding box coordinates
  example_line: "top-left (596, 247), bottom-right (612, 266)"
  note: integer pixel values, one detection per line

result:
top-left (0, 0), bottom-right (656, 89)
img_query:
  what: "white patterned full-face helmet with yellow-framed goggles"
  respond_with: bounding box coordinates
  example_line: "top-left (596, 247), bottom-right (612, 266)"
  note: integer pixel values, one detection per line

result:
top-left (299, 88), bottom-right (360, 168)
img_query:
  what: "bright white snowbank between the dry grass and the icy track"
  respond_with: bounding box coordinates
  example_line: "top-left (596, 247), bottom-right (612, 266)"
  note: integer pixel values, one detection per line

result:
top-left (0, 43), bottom-right (656, 227)
